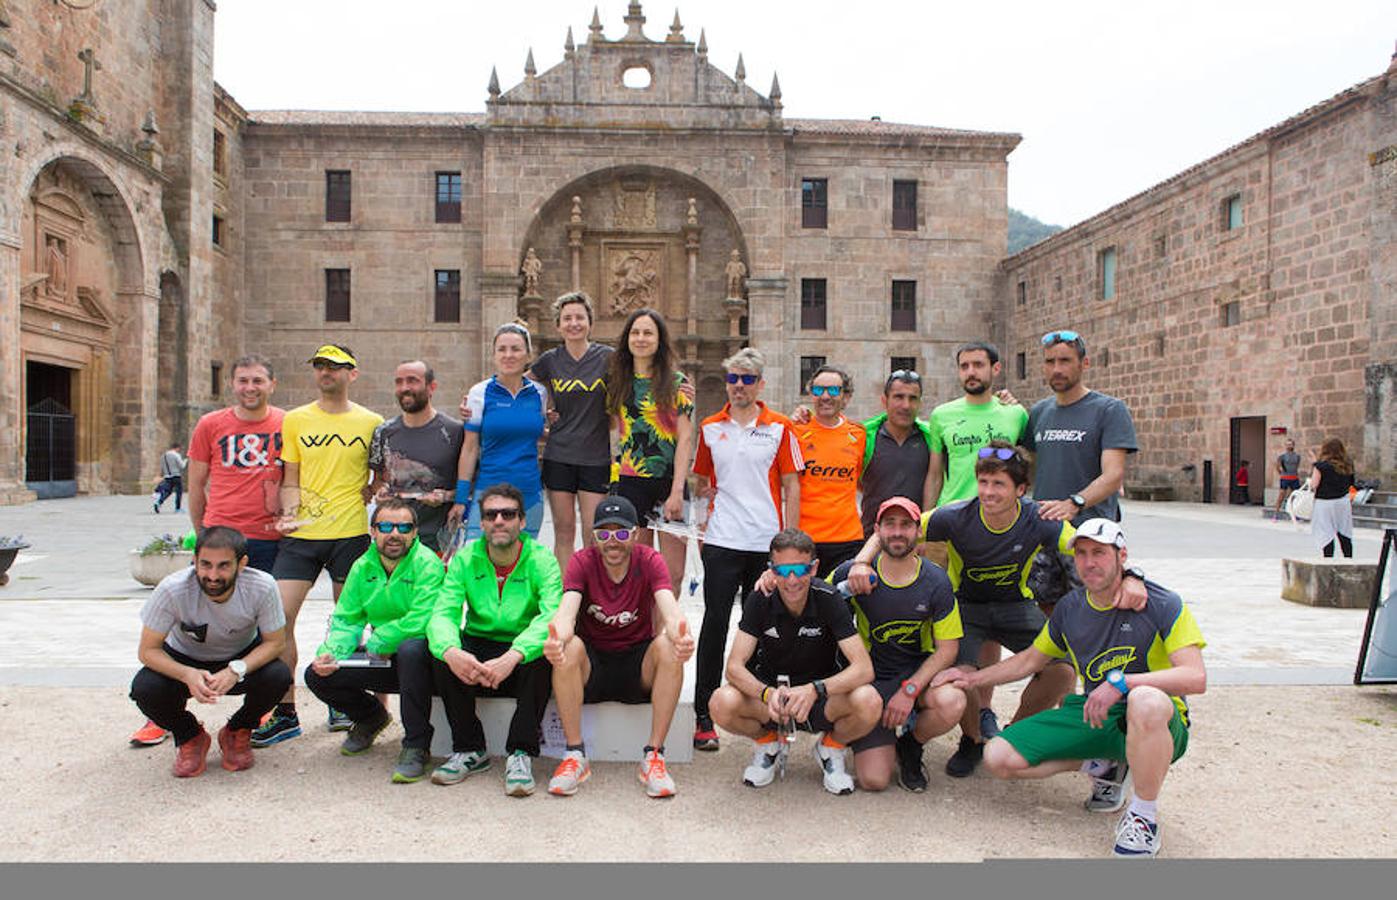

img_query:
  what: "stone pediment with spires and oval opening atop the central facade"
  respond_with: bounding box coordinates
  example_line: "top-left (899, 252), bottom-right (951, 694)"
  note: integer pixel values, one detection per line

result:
top-left (486, 3), bottom-right (781, 130)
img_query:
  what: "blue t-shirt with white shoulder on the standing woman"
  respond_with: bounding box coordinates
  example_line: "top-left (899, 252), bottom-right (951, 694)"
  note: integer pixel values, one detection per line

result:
top-left (465, 377), bottom-right (548, 507)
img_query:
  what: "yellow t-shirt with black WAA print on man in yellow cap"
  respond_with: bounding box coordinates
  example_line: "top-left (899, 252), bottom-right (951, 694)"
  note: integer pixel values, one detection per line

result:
top-left (281, 402), bottom-right (383, 541)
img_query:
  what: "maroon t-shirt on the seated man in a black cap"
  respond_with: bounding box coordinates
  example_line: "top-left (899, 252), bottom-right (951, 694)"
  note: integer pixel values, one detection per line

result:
top-left (563, 545), bottom-right (673, 653)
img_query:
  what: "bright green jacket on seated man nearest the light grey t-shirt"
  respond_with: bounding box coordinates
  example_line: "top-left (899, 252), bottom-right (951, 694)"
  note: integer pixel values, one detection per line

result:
top-left (316, 541), bottom-right (444, 660)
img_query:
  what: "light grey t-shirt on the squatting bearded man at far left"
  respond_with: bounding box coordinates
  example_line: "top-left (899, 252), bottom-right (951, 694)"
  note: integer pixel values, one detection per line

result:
top-left (141, 566), bottom-right (286, 662)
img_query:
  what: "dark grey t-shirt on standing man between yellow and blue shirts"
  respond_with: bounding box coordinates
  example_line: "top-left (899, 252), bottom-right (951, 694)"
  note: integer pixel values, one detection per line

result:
top-left (369, 412), bottom-right (465, 549)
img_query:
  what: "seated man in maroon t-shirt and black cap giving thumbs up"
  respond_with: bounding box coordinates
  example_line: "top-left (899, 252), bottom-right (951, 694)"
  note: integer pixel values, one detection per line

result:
top-left (543, 496), bottom-right (694, 797)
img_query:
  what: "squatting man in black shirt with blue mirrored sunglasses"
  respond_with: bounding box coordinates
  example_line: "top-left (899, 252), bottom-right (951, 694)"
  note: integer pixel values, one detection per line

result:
top-left (708, 528), bottom-right (883, 794)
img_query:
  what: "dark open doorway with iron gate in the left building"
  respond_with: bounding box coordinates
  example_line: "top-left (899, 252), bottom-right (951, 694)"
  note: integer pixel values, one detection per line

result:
top-left (24, 362), bottom-right (78, 500)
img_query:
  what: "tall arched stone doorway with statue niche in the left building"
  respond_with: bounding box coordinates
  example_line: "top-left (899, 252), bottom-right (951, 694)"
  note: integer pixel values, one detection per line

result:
top-left (18, 155), bottom-right (149, 495)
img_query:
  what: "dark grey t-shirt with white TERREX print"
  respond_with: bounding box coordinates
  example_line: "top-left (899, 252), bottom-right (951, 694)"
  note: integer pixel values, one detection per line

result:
top-left (1023, 391), bottom-right (1140, 525)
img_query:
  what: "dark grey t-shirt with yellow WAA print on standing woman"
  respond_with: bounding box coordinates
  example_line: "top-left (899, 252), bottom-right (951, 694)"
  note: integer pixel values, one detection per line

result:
top-left (531, 344), bottom-right (615, 465)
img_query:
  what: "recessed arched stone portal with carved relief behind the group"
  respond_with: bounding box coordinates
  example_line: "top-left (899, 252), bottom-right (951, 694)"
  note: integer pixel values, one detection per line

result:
top-left (517, 165), bottom-right (750, 415)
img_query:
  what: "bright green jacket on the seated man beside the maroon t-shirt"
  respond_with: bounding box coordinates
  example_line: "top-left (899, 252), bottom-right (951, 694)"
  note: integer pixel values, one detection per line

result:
top-left (427, 534), bottom-right (563, 662)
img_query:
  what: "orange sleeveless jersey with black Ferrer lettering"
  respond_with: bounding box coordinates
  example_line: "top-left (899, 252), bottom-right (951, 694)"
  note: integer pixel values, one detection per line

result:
top-left (795, 419), bottom-right (868, 544)
